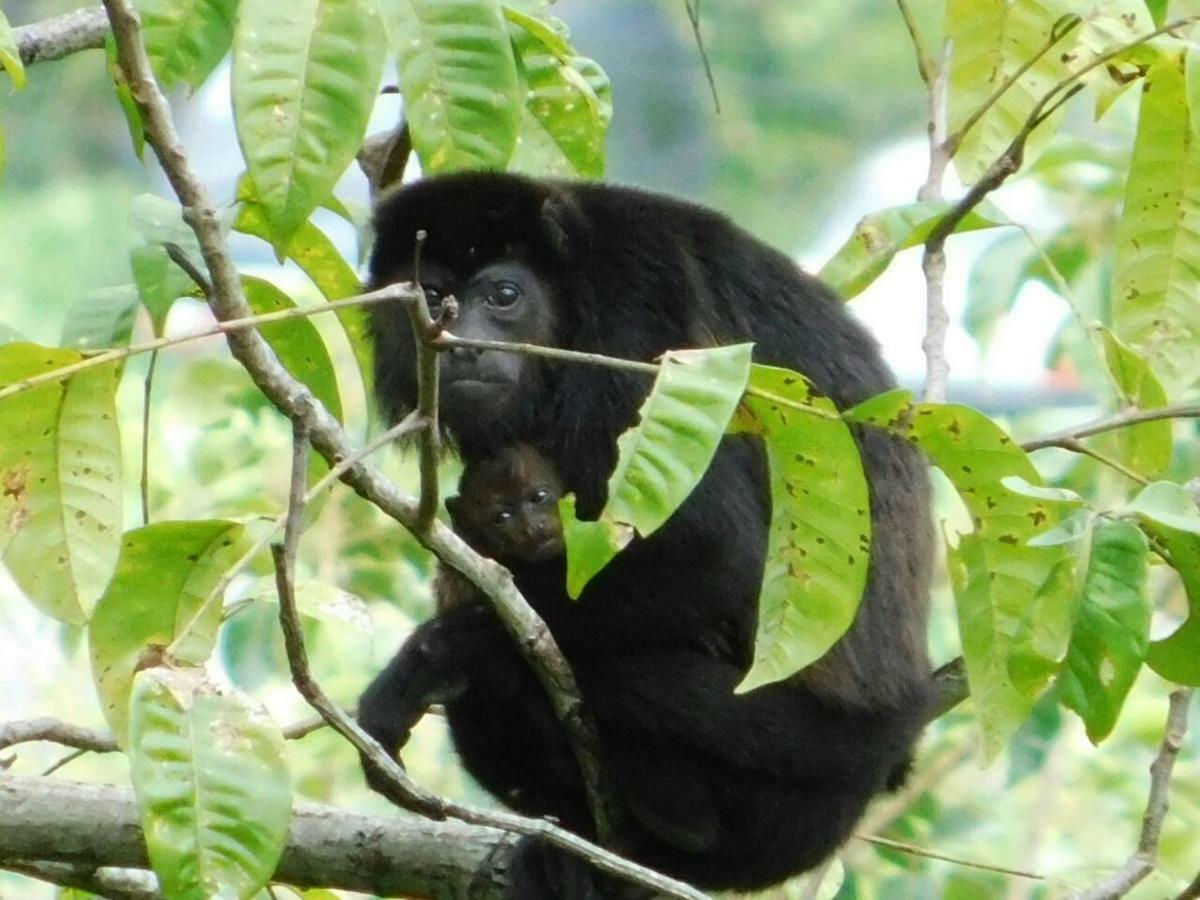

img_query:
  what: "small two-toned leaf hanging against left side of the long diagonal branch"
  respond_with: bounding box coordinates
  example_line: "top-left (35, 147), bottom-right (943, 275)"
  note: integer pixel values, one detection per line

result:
top-left (130, 193), bottom-right (204, 336)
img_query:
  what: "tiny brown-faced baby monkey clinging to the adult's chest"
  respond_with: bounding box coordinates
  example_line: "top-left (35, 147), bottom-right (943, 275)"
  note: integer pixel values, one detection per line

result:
top-left (433, 444), bottom-right (564, 612)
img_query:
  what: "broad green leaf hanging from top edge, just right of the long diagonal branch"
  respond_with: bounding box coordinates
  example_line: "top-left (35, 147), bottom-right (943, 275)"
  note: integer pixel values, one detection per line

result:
top-left (233, 0), bottom-right (385, 248)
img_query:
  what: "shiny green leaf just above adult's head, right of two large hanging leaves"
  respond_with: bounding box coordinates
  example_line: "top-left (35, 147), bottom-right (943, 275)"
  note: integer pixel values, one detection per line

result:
top-left (504, 6), bottom-right (612, 178)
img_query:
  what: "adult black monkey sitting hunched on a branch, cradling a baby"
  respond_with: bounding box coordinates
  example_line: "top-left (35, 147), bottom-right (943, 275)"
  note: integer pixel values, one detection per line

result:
top-left (359, 174), bottom-right (931, 900)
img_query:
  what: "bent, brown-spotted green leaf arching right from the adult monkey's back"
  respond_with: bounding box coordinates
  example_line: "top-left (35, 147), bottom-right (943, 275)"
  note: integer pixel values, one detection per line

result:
top-left (846, 391), bottom-right (1074, 757)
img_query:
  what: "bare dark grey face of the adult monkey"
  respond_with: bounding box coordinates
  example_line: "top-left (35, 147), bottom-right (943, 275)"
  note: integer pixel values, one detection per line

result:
top-left (421, 260), bottom-right (558, 437)
